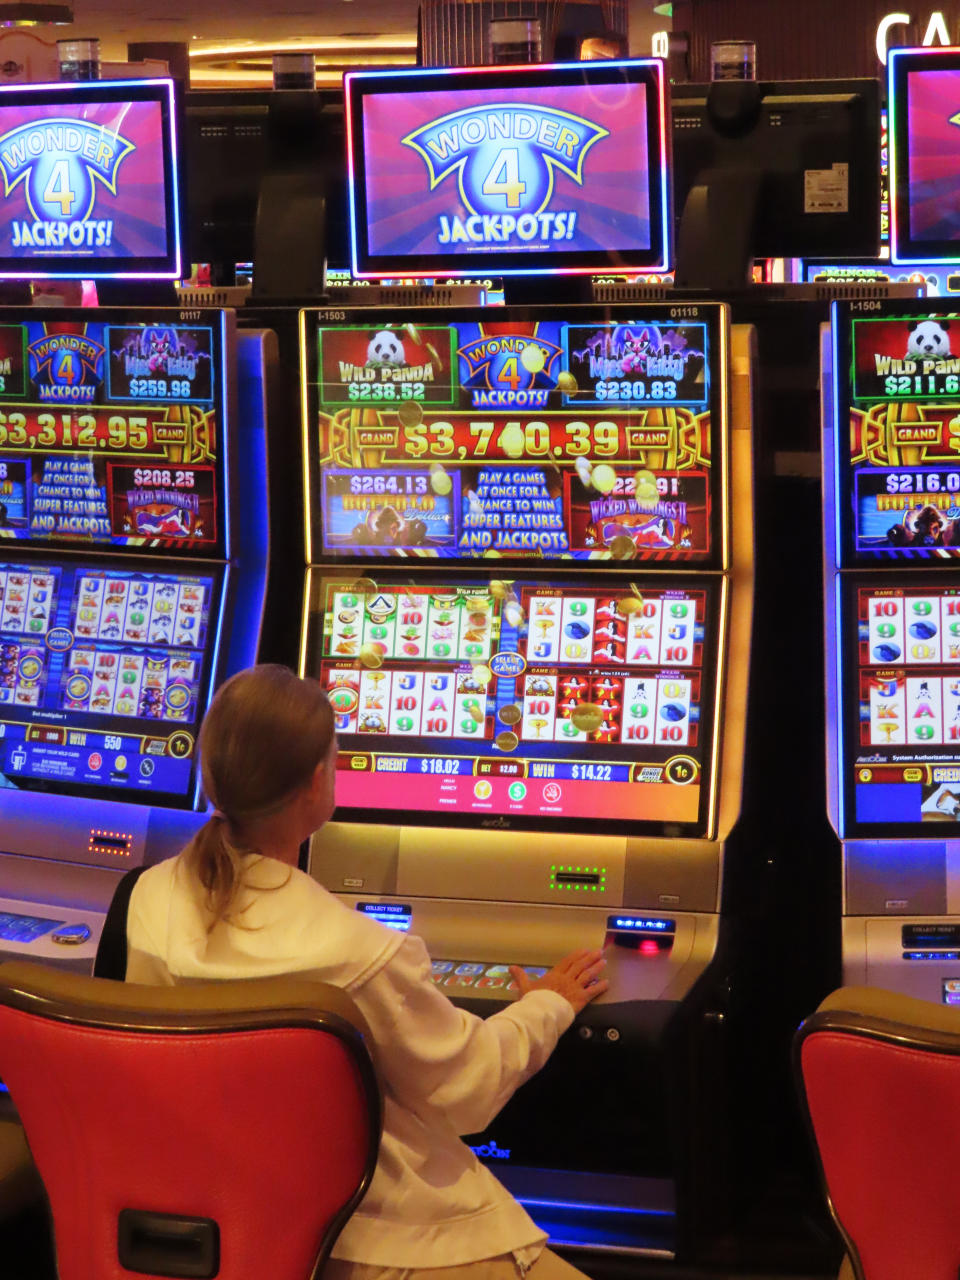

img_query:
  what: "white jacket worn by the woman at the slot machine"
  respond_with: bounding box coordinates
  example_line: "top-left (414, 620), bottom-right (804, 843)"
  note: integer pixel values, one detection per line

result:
top-left (127, 856), bottom-right (573, 1267)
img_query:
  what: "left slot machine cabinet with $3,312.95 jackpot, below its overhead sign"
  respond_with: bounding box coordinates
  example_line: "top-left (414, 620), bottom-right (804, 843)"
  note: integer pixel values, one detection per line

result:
top-left (0, 307), bottom-right (275, 969)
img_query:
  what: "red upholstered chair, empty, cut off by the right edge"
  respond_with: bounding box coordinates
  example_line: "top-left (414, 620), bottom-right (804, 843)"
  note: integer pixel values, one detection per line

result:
top-left (794, 987), bottom-right (960, 1280)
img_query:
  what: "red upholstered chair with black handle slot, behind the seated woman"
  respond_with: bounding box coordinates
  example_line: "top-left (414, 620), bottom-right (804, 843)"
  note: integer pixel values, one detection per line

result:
top-left (0, 961), bottom-right (381, 1280)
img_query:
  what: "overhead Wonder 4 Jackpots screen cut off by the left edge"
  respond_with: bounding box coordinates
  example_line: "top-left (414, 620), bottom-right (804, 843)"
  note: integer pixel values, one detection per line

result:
top-left (0, 79), bottom-right (182, 280)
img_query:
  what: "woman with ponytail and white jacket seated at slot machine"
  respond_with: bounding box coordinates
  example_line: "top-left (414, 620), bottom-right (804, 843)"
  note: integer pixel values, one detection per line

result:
top-left (96, 666), bottom-right (607, 1280)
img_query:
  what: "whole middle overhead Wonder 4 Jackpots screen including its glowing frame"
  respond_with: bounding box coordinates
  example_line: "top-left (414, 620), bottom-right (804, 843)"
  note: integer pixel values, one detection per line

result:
top-left (344, 59), bottom-right (671, 276)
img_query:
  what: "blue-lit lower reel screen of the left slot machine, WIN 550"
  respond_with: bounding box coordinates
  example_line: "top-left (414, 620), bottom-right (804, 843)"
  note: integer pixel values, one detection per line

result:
top-left (0, 555), bottom-right (224, 808)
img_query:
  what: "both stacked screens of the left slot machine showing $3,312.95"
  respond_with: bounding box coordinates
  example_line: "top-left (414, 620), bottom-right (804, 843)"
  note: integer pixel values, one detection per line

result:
top-left (0, 307), bottom-right (233, 808)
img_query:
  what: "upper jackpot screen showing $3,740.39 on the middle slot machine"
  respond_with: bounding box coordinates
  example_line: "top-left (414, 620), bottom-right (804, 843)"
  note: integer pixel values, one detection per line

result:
top-left (301, 305), bottom-right (727, 570)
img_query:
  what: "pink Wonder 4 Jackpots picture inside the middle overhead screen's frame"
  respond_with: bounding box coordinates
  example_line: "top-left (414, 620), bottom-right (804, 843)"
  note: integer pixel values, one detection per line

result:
top-left (365, 84), bottom-right (649, 255)
